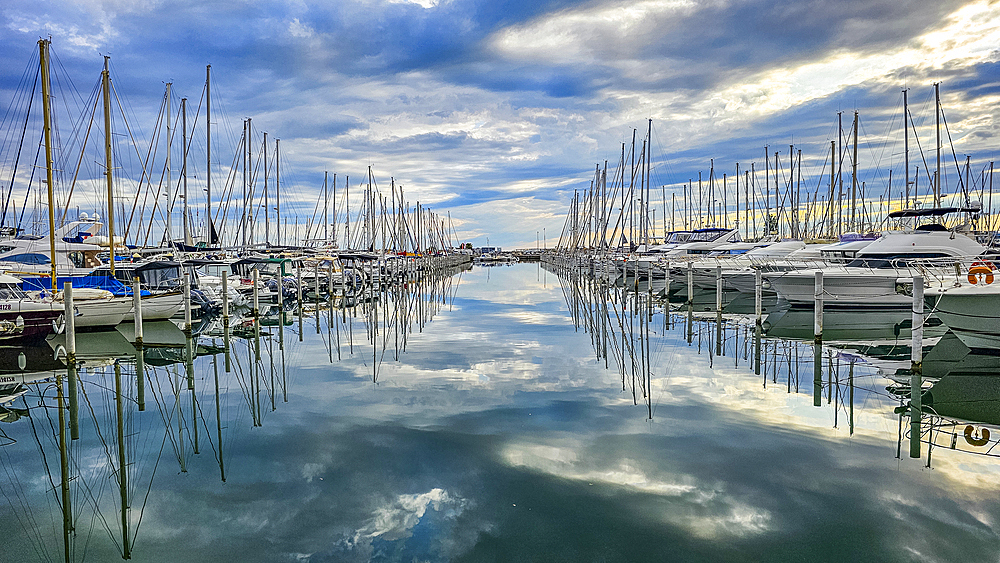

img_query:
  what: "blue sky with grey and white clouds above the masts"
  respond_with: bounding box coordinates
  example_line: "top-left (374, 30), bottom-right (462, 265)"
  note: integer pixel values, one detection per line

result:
top-left (0, 0), bottom-right (1000, 247)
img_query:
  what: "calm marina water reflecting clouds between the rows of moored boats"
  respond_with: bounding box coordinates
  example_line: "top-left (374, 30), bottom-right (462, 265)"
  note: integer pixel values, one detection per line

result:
top-left (0, 265), bottom-right (1000, 562)
